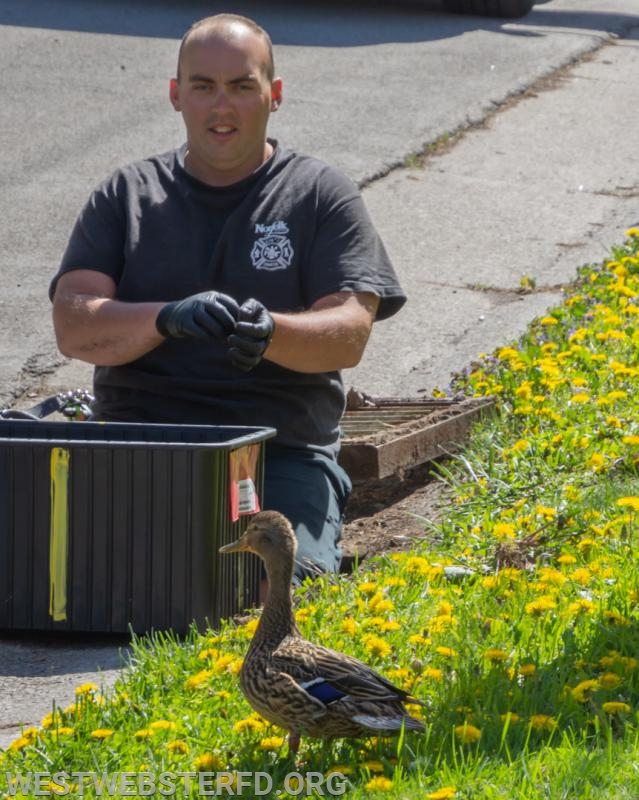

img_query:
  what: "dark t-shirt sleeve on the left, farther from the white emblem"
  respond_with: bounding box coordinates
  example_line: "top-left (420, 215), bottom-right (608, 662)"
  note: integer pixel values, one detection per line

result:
top-left (49, 176), bottom-right (126, 299)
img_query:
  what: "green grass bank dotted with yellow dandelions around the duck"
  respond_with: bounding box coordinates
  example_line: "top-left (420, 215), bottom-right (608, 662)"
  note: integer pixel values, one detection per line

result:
top-left (0, 230), bottom-right (639, 800)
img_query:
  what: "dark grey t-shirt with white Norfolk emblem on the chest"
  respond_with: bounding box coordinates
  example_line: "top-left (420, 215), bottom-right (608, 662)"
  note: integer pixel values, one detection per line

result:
top-left (50, 142), bottom-right (406, 457)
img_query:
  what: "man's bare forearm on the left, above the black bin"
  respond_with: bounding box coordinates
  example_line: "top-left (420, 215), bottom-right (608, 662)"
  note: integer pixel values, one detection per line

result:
top-left (53, 292), bottom-right (163, 366)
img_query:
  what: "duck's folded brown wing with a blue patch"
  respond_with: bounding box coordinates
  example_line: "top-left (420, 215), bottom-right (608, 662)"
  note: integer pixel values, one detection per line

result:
top-left (272, 636), bottom-right (421, 704)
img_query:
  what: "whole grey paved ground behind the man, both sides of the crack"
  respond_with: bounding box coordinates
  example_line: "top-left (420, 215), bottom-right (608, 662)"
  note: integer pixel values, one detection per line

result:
top-left (0, 0), bottom-right (639, 746)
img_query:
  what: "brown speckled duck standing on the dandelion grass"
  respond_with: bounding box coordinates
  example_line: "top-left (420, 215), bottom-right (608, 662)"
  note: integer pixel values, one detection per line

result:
top-left (220, 511), bottom-right (424, 754)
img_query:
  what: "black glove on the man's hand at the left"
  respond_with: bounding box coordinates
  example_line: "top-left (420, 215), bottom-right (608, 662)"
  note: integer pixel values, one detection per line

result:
top-left (155, 292), bottom-right (240, 339)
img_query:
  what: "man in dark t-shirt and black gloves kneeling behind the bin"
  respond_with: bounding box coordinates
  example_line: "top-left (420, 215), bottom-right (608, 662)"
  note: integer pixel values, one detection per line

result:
top-left (50, 14), bottom-right (405, 580)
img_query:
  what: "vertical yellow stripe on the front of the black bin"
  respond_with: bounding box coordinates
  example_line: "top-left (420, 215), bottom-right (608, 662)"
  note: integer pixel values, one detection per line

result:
top-left (49, 447), bottom-right (70, 622)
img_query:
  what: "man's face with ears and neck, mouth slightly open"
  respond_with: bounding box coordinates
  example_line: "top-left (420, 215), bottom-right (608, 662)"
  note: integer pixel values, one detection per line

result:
top-left (170, 29), bottom-right (282, 186)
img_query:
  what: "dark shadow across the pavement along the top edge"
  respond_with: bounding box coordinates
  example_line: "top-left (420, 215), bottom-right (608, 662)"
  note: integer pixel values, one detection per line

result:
top-left (0, 0), bottom-right (639, 47)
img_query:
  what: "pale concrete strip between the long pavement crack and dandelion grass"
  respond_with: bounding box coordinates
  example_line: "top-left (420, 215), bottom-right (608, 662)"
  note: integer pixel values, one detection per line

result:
top-left (0, 25), bottom-right (639, 746)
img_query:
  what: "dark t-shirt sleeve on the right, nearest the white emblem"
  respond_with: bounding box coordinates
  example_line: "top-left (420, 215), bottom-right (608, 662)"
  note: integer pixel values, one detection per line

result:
top-left (305, 168), bottom-right (406, 320)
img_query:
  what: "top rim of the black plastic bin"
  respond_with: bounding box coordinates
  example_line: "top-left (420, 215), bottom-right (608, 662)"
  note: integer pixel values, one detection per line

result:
top-left (0, 419), bottom-right (277, 450)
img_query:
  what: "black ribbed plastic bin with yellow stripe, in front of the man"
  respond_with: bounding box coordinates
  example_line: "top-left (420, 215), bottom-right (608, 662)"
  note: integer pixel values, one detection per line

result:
top-left (0, 420), bottom-right (275, 633)
